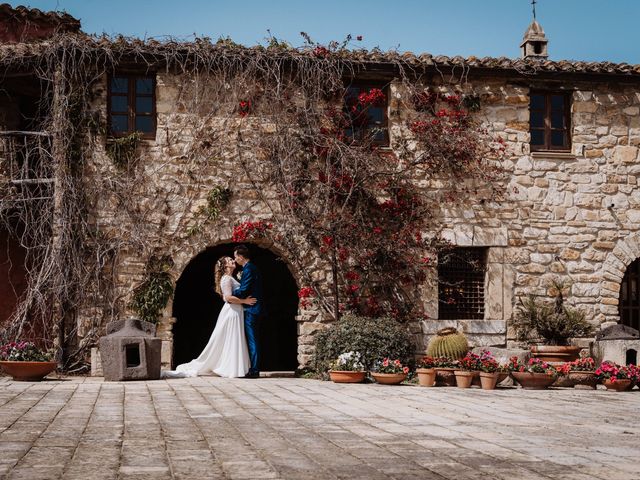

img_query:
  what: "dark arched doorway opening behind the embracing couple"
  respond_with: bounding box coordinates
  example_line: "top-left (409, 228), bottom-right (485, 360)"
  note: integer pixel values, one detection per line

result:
top-left (173, 243), bottom-right (298, 371)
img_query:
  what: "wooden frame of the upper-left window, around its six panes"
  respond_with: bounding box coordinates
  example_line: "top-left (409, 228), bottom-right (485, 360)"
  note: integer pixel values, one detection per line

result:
top-left (107, 72), bottom-right (158, 140)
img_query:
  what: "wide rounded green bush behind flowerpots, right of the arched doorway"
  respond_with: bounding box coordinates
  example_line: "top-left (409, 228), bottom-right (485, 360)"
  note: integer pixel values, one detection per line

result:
top-left (311, 315), bottom-right (414, 373)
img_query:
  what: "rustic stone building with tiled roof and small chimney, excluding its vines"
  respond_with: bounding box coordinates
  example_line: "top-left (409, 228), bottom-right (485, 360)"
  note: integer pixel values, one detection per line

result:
top-left (0, 6), bottom-right (640, 370)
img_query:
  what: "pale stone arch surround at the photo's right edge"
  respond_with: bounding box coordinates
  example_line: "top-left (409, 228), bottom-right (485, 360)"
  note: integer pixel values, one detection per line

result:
top-left (600, 232), bottom-right (640, 328)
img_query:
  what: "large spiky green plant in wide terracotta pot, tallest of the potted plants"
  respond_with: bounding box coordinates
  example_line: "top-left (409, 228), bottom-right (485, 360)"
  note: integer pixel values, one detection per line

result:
top-left (514, 280), bottom-right (593, 364)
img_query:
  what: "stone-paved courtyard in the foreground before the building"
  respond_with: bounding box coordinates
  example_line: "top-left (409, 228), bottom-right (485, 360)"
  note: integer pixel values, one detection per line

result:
top-left (0, 377), bottom-right (640, 480)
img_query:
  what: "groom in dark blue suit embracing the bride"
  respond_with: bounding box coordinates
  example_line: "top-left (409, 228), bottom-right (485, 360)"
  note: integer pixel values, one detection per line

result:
top-left (233, 245), bottom-right (265, 378)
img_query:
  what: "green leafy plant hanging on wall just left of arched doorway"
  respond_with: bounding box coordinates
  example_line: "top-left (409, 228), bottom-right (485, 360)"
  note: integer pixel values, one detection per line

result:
top-left (131, 255), bottom-right (173, 323)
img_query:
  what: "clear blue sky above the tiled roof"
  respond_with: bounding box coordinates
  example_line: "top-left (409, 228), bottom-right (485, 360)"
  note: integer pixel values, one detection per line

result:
top-left (10, 0), bottom-right (640, 63)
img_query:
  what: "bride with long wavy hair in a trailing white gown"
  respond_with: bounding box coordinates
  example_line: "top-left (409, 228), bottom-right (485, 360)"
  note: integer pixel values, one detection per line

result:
top-left (162, 257), bottom-right (256, 378)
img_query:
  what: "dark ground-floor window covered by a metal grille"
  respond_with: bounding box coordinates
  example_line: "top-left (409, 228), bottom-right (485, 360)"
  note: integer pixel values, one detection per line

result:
top-left (438, 247), bottom-right (486, 320)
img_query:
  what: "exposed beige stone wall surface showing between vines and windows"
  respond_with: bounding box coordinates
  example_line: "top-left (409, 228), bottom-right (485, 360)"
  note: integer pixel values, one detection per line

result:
top-left (79, 73), bottom-right (640, 365)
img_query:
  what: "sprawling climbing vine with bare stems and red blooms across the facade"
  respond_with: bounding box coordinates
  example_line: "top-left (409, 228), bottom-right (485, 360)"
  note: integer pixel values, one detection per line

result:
top-left (0, 30), bottom-right (504, 369)
